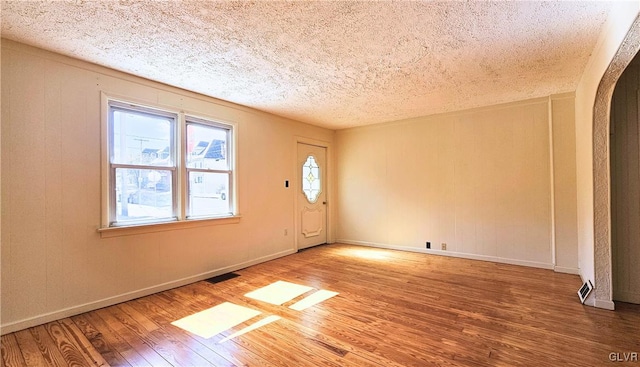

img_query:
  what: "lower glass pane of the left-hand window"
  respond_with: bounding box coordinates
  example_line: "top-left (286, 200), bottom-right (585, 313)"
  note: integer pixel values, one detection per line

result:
top-left (116, 168), bottom-right (173, 222)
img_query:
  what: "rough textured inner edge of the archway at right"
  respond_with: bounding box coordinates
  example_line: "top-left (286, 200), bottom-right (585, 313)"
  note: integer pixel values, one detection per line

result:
top-left (593, 14), bottom-right (640, 303)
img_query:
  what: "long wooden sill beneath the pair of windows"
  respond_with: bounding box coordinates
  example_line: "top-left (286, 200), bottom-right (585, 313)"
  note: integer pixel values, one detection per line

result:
top-left (98, 215), bottom-right (241, 238)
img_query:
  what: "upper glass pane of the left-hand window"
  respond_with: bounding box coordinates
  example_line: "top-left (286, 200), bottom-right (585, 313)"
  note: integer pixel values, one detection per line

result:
top-left (111, 109), bottom-right (174, 166)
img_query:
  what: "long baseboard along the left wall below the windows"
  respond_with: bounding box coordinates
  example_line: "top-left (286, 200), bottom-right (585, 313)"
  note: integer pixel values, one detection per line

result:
top-left (0, 249), bottom-right (296, 335)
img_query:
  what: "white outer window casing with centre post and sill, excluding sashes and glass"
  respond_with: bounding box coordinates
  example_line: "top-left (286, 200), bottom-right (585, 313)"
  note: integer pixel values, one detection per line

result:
top-left (97, 92), bottom-right (241, 238)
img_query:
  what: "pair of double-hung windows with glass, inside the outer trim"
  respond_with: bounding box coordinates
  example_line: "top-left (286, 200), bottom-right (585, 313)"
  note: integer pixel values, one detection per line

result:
top-left (105, 100), bottom-right (234, 227)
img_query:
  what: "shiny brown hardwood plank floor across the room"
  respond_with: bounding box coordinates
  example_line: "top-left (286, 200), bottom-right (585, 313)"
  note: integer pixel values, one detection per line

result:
top-left (1, 245), bottom-right (640, 367)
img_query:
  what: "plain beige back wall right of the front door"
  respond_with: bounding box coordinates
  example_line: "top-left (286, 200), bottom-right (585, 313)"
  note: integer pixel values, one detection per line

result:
top-left (336, 95), bottom-right (577, 272)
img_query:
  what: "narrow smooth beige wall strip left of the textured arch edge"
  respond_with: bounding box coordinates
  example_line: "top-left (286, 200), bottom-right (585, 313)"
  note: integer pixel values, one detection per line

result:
top-left (575, 1), bottom-right (640, 307)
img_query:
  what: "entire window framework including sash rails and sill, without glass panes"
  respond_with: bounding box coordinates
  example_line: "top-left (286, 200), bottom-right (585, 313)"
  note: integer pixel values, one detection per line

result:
top-left (98, 92), bottom-right (240, 237)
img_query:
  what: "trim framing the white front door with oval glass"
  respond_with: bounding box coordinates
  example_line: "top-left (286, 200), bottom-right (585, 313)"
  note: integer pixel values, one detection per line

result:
top-left (291, 136), bottom-right (335, 251)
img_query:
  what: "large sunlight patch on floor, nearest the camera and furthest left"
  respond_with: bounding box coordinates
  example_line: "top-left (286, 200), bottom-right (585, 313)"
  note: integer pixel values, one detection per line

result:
top-left (171, 302), bottom-right (262, 339)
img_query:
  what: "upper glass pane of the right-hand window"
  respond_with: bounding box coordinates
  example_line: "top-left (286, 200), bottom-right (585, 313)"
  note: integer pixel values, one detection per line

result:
top-left (187, 123), bottom-right (229, 170)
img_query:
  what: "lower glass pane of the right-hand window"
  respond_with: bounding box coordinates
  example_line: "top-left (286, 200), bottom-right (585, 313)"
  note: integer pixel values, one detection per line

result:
top-left (188, 172), bottom-right (231, 217)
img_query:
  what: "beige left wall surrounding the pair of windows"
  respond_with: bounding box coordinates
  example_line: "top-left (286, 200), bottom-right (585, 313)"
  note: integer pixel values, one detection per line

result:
top-left (1, 40), bottom-right (334, 333)
